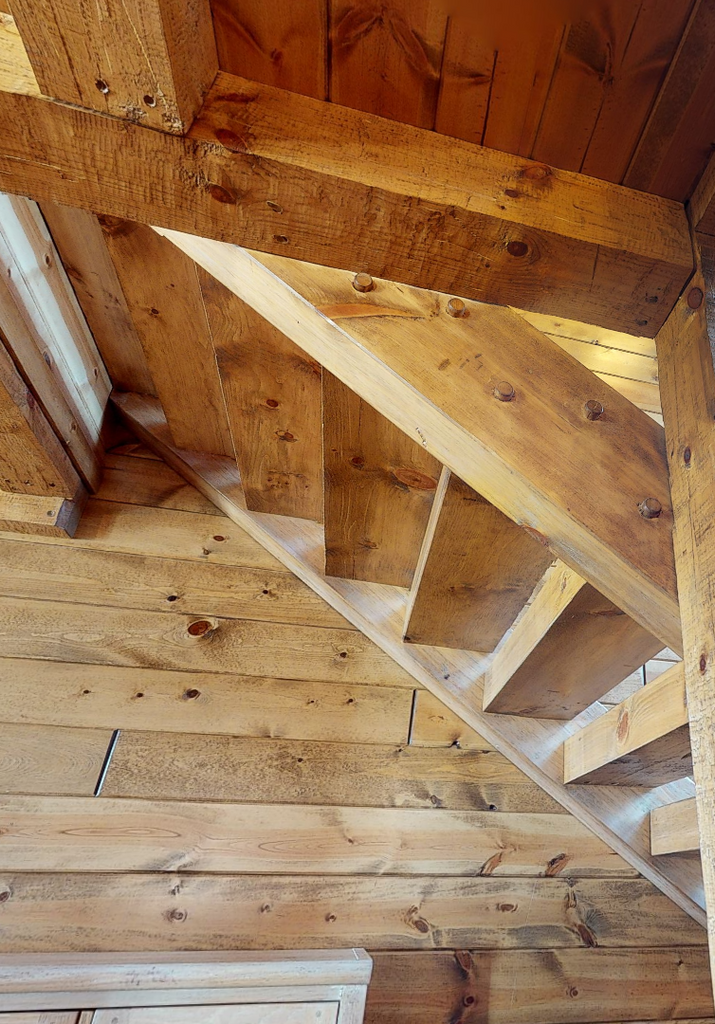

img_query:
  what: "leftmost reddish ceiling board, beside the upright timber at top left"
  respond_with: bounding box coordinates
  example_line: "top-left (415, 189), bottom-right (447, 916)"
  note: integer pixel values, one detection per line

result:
top-left (211, 0), bottom-right (328, 99)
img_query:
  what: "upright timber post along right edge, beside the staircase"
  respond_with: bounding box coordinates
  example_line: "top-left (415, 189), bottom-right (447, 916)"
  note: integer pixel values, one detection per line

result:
top-left (657, 236), bottom-right (715, 983)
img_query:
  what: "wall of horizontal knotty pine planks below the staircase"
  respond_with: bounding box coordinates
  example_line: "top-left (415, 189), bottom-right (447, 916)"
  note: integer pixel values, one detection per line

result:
top-left (0, 444), bottom-right (713, 1024)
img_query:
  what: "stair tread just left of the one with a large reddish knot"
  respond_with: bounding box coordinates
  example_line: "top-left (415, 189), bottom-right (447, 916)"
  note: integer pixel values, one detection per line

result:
top-left (199, 269), bottom-right (323, 522)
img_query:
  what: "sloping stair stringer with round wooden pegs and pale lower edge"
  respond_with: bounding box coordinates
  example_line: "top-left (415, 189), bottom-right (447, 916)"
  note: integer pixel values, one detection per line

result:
top-left (151, 231), bottom-right (681, 650)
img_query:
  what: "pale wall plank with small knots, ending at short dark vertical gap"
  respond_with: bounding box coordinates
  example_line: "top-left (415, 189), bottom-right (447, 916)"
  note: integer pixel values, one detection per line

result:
top-left (0, 658), bottom-right (413, 743)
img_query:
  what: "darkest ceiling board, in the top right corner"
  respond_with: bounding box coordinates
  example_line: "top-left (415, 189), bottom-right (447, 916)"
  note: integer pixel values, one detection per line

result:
top-left (623, 0), bottom-right (715, 202)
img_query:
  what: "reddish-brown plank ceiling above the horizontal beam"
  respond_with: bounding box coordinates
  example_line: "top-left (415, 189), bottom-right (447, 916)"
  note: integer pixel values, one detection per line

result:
top-left (212, 0), bottom-right (715, 202)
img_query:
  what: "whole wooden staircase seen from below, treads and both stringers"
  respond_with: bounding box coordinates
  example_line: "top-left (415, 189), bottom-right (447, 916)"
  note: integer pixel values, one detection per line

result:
top-left (94, 221), bottom-right (706, 924)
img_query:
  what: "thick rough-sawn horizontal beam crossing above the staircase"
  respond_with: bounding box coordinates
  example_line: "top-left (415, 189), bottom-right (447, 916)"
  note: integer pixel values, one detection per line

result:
top-left (0, 74), bottom-right (692, 336)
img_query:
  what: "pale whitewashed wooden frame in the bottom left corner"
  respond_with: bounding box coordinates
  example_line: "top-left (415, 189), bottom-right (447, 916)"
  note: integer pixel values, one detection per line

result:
top-left (0, 949), bottom-right (372, 1024)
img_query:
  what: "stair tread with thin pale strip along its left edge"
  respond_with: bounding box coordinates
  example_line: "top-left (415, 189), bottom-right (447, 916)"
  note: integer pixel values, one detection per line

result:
top-left (405, 469), bottom-right (553, 651)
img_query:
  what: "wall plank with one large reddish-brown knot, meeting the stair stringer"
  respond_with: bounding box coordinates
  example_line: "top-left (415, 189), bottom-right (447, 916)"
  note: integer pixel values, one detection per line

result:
top-left (0, 598), bottom-right (405, 689)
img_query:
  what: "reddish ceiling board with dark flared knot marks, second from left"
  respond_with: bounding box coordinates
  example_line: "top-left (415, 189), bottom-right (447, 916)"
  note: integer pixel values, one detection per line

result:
top-left (330, 0), bottom-right (448, 128)
